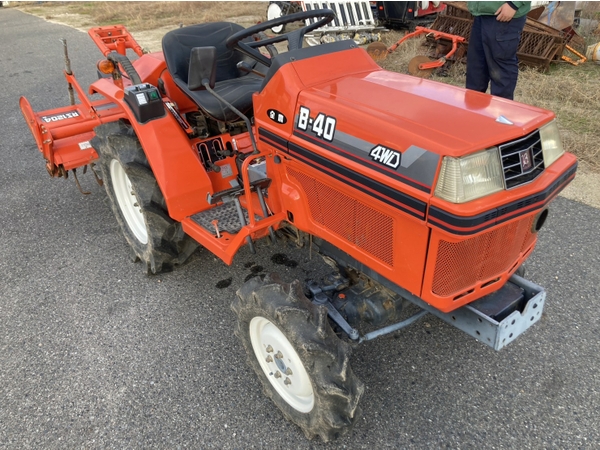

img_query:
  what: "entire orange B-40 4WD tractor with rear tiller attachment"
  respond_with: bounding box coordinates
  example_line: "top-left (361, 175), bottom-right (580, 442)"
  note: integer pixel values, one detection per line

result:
top-left (20, 10), bottom-right (577, 441)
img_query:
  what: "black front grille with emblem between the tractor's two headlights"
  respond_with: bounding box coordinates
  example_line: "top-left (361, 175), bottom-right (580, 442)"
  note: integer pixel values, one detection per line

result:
top-left (499, 131), bottom-right (544, 189)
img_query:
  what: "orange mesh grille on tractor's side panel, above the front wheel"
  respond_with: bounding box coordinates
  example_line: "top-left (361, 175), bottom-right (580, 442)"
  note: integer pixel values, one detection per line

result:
top-left (288, 168), bottom-right (394, 266)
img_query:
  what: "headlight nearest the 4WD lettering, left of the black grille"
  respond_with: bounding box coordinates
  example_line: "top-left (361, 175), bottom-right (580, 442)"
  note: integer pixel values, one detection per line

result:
top-left (435, 147), bottom-right (504, 203)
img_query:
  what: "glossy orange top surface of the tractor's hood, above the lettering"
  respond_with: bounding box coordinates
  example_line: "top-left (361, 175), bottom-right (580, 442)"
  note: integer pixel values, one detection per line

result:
top-left (299, 65), bottom-right (554, 157)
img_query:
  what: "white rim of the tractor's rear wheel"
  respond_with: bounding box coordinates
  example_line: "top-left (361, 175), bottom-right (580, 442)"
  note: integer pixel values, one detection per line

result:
top-left (110, 159), bottom-right (148, 244)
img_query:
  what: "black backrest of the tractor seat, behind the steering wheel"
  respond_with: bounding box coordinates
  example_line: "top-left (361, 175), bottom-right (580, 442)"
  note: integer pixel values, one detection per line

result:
top-left (162, 22), bottom-right (243, 87)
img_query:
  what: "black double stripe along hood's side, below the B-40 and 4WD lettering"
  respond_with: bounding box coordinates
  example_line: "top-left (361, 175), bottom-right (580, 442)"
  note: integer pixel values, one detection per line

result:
top-left (289, 142), bottom-right (427, 220)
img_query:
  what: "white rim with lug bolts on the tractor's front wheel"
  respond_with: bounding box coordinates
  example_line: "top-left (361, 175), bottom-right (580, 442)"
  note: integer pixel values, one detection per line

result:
top-left (250, 316), bottom-right (315, 413)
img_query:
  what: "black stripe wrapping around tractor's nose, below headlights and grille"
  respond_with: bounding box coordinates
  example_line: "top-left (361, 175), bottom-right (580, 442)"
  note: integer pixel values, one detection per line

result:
top-left (429, 163), bottom-right (577, 235)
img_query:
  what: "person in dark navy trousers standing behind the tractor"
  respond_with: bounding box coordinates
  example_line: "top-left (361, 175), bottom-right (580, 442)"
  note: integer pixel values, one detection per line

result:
top-left (466, 1), bottom-right (531, 100)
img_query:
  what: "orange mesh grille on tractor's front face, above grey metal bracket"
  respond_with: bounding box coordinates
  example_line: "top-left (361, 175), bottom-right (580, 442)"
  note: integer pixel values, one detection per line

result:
top-left (432, 217), bottom-right (535, 297)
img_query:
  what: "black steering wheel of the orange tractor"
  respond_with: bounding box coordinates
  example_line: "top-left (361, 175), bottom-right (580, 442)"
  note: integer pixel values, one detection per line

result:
top-left (225, 9), bottom-right (335, 67)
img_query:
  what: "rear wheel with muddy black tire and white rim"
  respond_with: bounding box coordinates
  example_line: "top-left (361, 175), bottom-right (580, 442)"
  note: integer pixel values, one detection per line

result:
top-left (91, 121), bottom-right (197, 274)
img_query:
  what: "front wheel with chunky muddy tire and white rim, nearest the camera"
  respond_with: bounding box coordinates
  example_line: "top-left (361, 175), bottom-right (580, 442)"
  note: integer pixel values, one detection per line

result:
top-left (232, 275), bottom-right (364, 442)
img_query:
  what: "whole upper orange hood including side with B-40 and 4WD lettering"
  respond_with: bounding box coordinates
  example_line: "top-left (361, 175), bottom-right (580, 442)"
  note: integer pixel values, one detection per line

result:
top-left (256, 43), bottom-right (554, 199)
